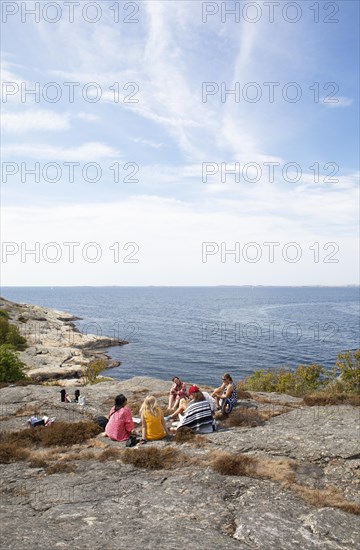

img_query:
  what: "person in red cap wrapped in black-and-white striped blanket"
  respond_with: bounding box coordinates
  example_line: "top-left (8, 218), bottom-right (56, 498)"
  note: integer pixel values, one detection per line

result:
top-left (177, 386), bottom-right (216, 434)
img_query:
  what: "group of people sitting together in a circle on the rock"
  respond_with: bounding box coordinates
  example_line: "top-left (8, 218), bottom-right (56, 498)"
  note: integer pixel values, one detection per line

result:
top-left (105, 373), bottom-right (237, 443)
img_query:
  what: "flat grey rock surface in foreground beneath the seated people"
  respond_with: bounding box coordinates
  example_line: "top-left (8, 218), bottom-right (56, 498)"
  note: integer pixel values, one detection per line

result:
top-left (0, 377), bottom-right (360, 550)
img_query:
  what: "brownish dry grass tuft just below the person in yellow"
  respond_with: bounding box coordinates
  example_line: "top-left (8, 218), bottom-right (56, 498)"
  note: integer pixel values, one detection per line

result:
top-left (121, 446), bottom-right (180, 470)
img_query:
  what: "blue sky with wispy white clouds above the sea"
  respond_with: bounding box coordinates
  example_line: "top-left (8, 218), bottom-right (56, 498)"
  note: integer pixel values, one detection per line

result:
top-left (1, 0), bottom-right (359, 286)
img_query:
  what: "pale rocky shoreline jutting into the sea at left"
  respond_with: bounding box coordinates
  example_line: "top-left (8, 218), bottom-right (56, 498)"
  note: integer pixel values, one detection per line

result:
top-left (0, 298), bottom-right (128, 385)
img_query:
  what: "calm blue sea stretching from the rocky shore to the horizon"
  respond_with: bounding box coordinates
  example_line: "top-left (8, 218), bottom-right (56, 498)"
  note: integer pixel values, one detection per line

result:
top-left (2, 287), bottom-right (359, 385)
